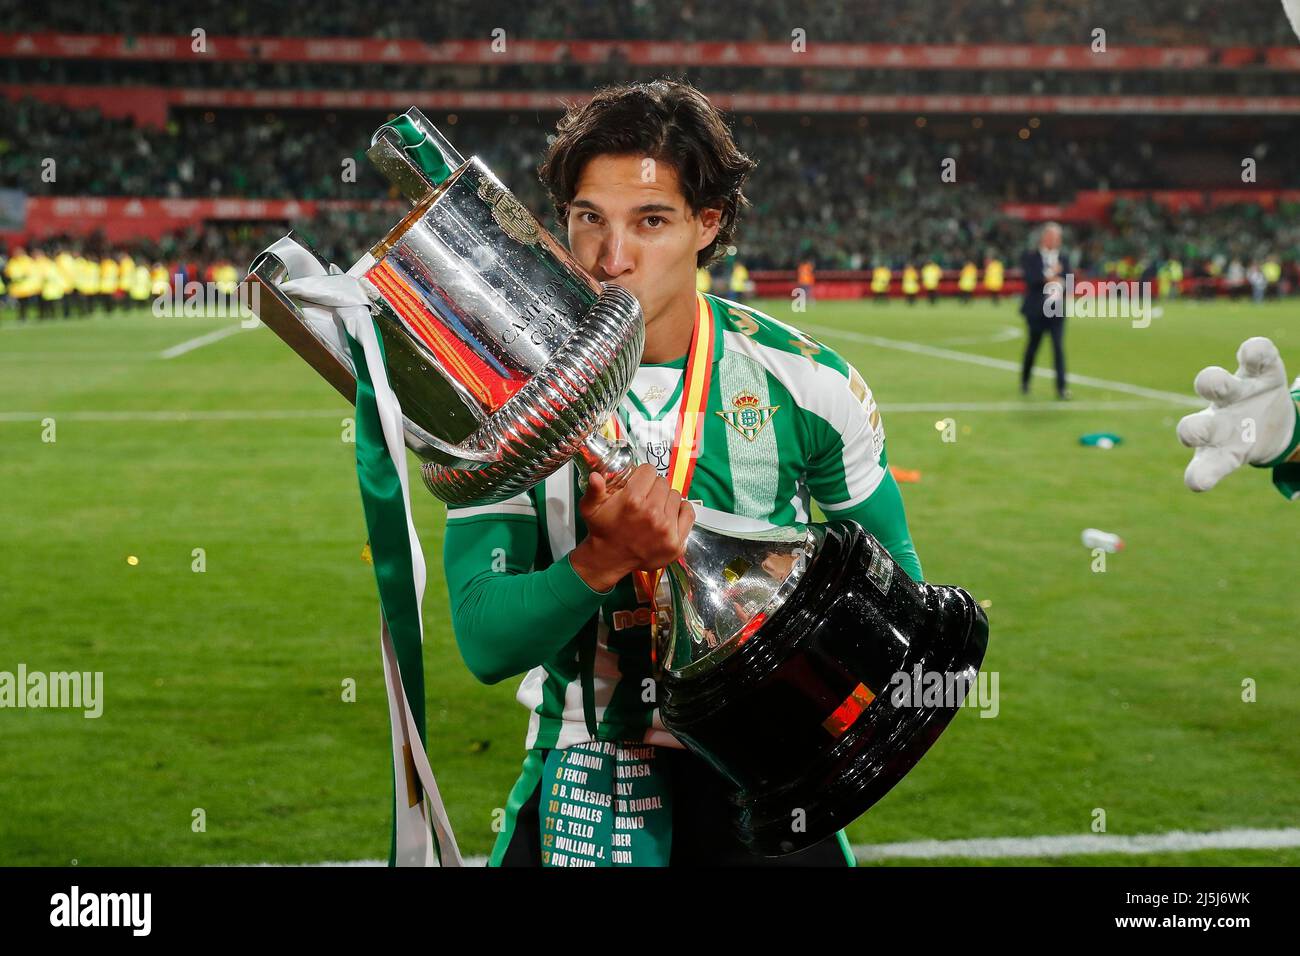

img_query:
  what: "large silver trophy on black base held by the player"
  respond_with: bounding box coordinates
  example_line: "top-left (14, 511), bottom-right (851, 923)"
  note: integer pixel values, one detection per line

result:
top-left (246, 109), bottom-right (987, 855)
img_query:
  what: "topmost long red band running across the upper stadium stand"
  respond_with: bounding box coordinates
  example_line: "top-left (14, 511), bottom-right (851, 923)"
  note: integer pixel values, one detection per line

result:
top-left (0, 30), bottom-right (1284, 70)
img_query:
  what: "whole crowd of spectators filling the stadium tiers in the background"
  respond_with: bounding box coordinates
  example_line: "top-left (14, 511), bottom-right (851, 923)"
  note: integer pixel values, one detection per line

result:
top-left (0, 0), bottom-right (1300, 304)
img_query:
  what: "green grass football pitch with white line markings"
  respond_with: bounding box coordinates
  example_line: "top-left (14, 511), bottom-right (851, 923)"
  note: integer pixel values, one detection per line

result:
top-left (0, 300), bottom-right (1300, 866)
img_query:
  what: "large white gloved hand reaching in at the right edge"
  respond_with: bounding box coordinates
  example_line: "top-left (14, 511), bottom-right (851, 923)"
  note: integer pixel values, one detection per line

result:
top-left (1178, 336), bottom-right (1296, 492)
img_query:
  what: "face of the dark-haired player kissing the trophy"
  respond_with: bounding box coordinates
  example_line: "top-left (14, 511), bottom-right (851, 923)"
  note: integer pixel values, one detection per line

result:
top-left (568, 155), bottom-right (720, 325)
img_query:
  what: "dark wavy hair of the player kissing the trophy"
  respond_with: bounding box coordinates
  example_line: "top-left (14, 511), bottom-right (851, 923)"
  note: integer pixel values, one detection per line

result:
top-left (537, 79), bottom-right (758, 265)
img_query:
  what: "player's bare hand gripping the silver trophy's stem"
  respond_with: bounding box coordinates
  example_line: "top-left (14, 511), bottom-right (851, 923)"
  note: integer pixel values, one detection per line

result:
top-left (569, 464), bottom-right (696, 591)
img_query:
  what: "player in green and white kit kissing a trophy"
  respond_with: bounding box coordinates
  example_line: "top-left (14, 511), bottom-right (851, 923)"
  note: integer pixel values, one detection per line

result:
top-left (443, 81), bottom-right (922, 866)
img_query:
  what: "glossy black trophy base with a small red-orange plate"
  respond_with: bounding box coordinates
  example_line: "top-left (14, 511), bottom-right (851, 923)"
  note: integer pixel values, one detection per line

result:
top-left (662, 522), bottom-right (988, 856)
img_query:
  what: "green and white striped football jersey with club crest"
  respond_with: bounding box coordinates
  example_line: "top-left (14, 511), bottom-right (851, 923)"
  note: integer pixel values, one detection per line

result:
top-left (447, 295), bottom-right (919, 749)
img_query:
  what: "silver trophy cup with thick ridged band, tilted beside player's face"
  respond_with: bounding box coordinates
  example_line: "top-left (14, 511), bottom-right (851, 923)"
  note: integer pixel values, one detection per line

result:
top-left (246, 157), bottom-right (645, 505)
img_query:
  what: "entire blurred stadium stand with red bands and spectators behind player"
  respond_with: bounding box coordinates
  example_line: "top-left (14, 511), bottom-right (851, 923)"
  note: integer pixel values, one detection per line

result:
top-left (0, 0), bottom-right (1300, 308)
